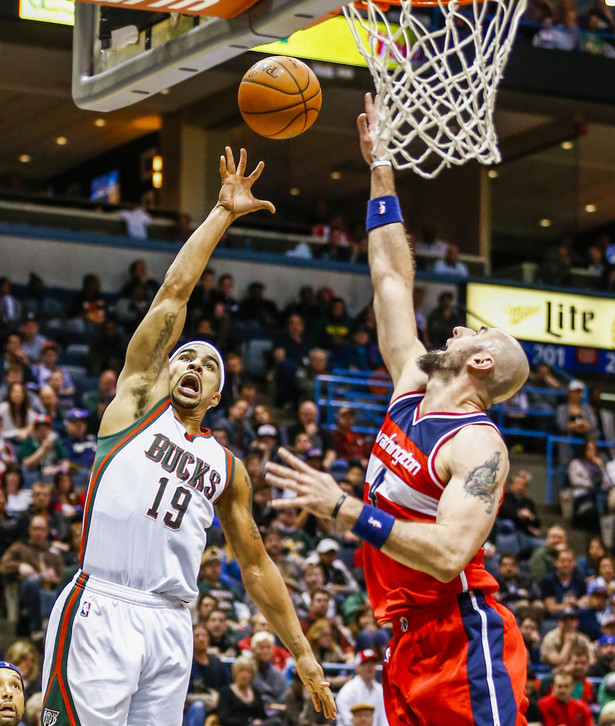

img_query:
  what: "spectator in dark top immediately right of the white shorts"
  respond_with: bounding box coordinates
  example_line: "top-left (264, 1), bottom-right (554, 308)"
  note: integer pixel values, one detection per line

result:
top-left (184, 623), bottom-right (230, 726)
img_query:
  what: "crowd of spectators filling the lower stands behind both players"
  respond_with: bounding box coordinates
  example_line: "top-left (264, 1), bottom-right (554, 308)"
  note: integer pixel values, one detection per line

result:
top-left (0, 253), bottom-right (615, 726)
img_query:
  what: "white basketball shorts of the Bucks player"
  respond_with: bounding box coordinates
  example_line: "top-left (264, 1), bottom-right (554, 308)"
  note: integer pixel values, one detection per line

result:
top-left (42, 571), bottom-right (193, 726)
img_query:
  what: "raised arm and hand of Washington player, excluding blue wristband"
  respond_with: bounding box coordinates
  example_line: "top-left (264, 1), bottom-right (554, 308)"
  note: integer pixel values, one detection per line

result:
top-left (357, 93), bottom-right (427, 393)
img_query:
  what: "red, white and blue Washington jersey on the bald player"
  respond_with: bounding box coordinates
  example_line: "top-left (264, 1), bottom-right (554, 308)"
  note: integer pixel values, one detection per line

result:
top-left (363, 392), bottom-right (499, 622)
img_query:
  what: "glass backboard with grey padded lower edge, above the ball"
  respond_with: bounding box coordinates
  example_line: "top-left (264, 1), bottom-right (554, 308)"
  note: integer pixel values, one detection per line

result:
top-left (72, 0), bottom-right (339, 111)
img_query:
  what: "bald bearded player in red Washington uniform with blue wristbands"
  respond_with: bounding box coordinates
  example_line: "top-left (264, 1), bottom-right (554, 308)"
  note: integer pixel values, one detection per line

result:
top-left (266, 94), bottom-right (529, 726)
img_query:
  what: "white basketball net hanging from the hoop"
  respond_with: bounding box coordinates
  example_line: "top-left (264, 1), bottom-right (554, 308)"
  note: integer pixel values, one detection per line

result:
top-left (343, 0), bottom-right (526, 179)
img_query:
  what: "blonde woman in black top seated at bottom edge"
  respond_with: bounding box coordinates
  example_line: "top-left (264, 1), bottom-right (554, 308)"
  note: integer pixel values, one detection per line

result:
top-left (218, 655), bottom-right (271, 726)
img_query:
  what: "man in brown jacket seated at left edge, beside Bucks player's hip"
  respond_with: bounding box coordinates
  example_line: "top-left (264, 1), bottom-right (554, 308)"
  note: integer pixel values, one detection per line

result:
top-left (0, 515), bottom-right (64, 640)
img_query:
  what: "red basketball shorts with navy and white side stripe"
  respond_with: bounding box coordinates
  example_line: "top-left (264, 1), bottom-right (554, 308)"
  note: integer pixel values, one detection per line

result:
top-left (382, 591), bottom-right (527, 726)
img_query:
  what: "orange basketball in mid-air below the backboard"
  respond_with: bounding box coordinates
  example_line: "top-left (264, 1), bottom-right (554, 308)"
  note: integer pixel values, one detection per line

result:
top-left (237, 56), bottom-right (322, 139)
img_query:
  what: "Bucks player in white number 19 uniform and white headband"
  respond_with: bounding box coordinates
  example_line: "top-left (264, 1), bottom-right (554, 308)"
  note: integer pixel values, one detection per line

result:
top-left (43, 147), bottom-right (335, 726)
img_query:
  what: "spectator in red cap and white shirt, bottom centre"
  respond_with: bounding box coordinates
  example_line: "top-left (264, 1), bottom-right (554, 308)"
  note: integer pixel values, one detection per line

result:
top-left (335, 648), bottom-right (387, 726)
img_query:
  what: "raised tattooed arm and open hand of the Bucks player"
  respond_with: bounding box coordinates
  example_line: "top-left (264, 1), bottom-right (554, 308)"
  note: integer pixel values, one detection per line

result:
top-left (100, 146), bottom-right (275, 435)
